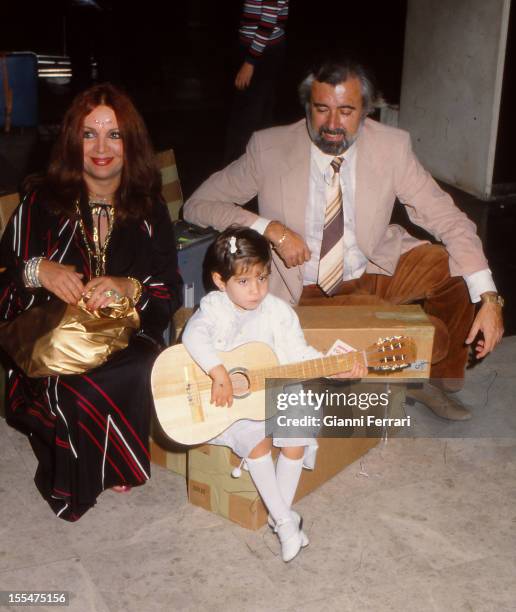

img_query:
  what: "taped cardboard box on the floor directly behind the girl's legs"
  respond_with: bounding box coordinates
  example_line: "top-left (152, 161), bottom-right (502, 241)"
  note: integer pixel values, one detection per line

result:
top-left (187, 383), bottom-right (405, 530)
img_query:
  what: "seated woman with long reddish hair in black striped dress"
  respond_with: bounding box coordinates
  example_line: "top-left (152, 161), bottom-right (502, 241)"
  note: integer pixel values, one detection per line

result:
top-left (0, 84), bottom-right (179, 521)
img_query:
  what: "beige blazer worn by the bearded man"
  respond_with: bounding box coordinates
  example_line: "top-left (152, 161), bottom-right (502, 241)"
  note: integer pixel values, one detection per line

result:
top-left (184, 119), bottom-right (488, 304)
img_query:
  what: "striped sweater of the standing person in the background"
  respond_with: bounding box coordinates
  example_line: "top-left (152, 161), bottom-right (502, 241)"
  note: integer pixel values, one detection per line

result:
top-left (238, 0), bottom-right (288, 64)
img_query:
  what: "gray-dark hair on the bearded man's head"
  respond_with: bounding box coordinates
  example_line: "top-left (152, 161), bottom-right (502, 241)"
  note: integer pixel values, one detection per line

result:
top-left (298, 60), bottom-right (376, 117)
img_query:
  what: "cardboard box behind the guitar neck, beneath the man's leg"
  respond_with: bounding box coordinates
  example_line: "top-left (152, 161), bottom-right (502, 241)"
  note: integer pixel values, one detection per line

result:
top-left (295, 304), bottom-right (434, 379)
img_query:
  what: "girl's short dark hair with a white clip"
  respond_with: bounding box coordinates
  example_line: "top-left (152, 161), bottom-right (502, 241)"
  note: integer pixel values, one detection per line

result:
top-left (206, 225), bottom-right (272, 282)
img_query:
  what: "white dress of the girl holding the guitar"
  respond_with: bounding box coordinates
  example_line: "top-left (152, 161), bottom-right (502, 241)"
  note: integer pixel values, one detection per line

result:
top-left (182, 291), bottom-right (322, 469)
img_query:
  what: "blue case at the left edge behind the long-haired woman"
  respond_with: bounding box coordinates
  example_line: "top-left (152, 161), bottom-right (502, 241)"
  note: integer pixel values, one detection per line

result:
top-left (0, 52), bottom-right (38, 127)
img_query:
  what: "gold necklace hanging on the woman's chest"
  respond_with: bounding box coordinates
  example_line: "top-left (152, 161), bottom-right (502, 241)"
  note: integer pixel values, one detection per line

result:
top-left (75, 194), bottom-right (115, 276)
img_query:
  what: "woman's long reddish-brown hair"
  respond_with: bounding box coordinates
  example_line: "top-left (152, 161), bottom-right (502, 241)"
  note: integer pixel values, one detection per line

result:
top-left (24, 83), bottom-right (161, 219)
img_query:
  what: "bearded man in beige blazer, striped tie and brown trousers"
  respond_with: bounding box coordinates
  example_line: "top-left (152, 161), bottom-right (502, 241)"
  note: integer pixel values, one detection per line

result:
top-left (184, 62), bottom-right (503, 420)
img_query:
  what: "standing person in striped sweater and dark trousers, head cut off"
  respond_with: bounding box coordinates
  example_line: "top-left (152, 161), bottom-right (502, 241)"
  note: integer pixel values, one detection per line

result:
top-left (224, 0), bottom-right (288, 163)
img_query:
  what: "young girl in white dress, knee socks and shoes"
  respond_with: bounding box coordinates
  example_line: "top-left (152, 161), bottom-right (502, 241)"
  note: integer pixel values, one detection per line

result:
top-left (183, 226), bottom-right (366, 562)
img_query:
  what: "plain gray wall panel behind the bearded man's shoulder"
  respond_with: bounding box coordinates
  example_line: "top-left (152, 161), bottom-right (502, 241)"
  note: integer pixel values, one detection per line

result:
top-left (399, 0), bottom-right (510, 198)
